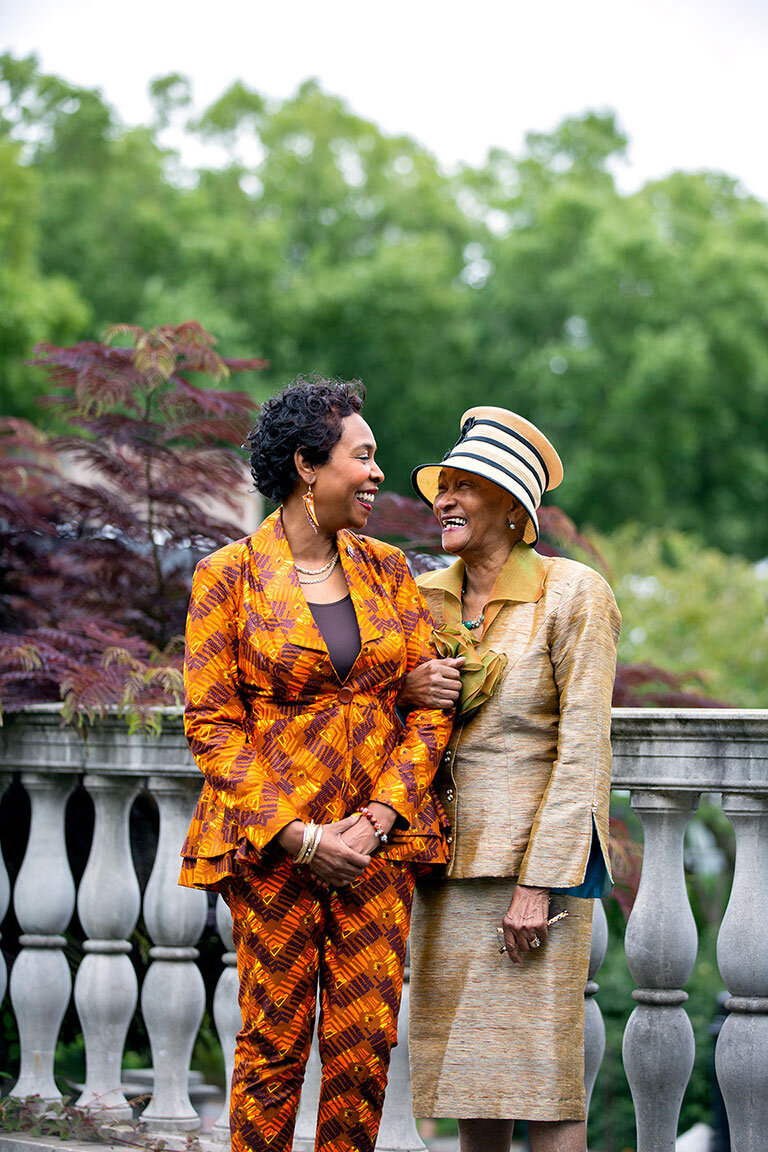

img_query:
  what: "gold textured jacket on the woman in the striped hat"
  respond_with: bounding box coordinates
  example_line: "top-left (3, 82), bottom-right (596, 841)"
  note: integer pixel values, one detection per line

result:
top-left (418, 544), bottom-right (621, 895)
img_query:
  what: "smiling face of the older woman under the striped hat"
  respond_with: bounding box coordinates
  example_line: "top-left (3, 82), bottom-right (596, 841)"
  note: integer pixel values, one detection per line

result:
top-left (433, 468), bottom-right (525, 559)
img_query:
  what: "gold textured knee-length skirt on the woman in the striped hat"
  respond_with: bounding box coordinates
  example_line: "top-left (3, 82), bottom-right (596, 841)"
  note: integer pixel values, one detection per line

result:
top-left (409, 877), bottom-right (593, 1120)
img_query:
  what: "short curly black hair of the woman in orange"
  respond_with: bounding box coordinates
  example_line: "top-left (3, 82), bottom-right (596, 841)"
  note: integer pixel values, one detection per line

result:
top-left (243, 373), bottom-right (365, 503)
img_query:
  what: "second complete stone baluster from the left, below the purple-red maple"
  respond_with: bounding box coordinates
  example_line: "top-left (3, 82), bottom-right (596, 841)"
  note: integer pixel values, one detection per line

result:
top-left (75, 773), bottom-right (140, 1119)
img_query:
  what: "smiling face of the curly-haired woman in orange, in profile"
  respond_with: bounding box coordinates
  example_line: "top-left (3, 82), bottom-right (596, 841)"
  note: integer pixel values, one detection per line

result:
top-left (312, 412), bottom-right (383, 532)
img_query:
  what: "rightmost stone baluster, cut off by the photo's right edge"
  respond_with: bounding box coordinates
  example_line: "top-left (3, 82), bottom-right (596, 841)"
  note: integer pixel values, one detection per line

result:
top-left (715, 793), bottom-right (768, 1152)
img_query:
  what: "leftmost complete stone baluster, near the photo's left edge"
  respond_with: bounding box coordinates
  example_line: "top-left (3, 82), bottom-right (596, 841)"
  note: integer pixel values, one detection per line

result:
top-left (10, 772), bottom-right (75, 1102)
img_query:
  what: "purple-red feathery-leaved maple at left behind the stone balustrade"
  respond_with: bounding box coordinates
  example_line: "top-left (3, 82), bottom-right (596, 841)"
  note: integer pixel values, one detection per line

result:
top-left (0, 323), bottom-right (264, 720)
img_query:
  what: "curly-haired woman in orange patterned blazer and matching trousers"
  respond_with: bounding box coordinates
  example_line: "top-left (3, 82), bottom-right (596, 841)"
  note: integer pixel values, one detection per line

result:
top-left (181, 380), bottom-right (451, 1152)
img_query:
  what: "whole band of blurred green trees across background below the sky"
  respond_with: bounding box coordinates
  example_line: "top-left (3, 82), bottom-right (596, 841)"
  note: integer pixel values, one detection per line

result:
top-left (6, 55), bottom-right (768, 558)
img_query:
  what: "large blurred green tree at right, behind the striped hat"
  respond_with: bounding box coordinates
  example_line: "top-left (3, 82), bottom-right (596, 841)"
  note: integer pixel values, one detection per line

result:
top-left (467, 115), bottom-right (768, 556)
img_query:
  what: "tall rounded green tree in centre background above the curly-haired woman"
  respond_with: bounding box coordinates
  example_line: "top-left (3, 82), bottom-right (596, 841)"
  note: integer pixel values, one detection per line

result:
top-left (188, 82), bottom-right (478, 472)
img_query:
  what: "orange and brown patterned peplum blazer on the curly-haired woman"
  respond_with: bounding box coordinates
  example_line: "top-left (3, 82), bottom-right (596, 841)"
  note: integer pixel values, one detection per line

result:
top-left (180, 510), bottom-right (453, 888)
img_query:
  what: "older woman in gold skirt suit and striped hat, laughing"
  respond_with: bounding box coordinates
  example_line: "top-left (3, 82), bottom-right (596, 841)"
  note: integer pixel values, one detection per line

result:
top-left (401, 407), bottom-right (619, 1152)
